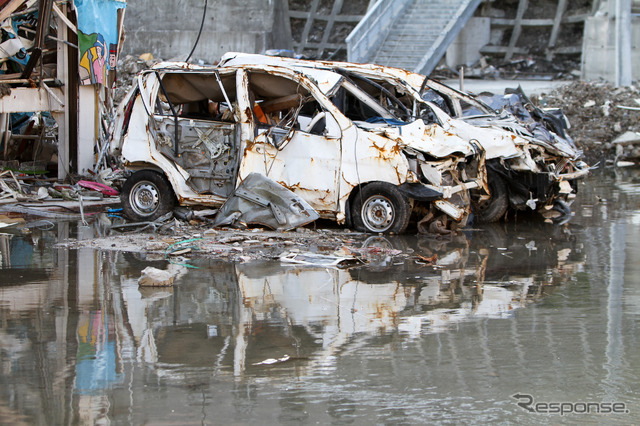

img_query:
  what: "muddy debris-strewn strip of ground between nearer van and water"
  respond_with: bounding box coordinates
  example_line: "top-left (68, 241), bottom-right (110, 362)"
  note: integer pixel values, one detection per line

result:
top-left (59, 215), bottom-right (440, 267)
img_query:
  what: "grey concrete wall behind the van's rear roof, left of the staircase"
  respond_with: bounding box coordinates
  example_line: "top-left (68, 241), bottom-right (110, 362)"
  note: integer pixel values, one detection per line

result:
top-left (122, 0), bottom-right (291, 63)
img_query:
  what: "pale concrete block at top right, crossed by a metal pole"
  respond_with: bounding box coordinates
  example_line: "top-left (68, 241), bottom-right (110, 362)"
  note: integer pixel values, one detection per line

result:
top-left (582, 16), bottom-right (640, 82)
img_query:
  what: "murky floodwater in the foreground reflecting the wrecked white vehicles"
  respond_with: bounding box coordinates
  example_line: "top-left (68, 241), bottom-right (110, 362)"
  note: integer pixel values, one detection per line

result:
top-left (0, 168), bottom-right (640, 424)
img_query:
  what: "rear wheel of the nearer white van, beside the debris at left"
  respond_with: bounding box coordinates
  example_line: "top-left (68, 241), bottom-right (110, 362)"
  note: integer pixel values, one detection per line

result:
top-left (120, 170), bottom-right (176, 222)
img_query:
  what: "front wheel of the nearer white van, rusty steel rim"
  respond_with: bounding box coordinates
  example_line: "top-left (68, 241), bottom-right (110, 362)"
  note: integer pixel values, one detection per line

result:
top-left (351, 182), bottom-right (411, 234)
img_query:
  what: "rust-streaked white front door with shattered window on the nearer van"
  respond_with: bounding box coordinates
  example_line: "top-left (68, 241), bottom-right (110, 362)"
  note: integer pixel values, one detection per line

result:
top-left (239, 70), bottom-right (342, 218)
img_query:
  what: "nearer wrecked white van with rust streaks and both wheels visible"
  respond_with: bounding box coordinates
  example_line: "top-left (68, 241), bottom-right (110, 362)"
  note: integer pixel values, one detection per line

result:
top-left (111, 63), bottom-right (484, 232)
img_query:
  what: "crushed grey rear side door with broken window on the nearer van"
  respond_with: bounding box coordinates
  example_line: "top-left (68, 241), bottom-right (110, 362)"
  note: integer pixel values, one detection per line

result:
top-left (154, 72), bottom-right (240, 197)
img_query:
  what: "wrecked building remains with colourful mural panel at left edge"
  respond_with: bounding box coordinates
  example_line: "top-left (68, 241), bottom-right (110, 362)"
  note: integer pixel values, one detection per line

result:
top-left (0, 0), bottom-right (126, 180)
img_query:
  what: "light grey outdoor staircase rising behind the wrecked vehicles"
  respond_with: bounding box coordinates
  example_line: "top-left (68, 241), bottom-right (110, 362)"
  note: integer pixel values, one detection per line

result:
top-left (347, 0), bottom-right (482, 75)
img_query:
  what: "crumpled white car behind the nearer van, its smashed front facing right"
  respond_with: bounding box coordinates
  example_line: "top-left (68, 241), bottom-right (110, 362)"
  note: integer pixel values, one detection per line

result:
top-left (220, 52), bottom-right (589, 222)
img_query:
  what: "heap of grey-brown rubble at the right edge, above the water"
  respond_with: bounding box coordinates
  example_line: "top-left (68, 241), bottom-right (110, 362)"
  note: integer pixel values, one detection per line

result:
top-left (532, 81), bottom-right (640, 166)
